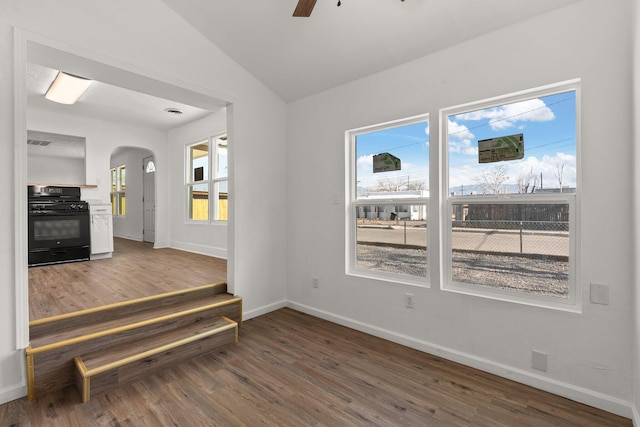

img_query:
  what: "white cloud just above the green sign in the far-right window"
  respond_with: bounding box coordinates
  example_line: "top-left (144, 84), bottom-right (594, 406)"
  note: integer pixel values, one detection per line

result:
top-left (455, 99), bottom-right (555, 130)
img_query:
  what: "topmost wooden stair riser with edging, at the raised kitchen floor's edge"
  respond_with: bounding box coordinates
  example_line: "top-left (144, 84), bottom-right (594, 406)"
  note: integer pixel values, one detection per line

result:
top-left (29, 283), bottom-right (227, 340)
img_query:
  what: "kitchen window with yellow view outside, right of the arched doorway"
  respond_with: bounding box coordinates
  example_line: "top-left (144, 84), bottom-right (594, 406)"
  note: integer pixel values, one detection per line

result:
top-left (186, 135), bottom-right (228, 221)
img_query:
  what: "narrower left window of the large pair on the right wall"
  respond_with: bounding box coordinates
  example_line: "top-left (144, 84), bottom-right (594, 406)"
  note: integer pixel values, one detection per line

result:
top-left (348, 116), bottom-right (429, 285)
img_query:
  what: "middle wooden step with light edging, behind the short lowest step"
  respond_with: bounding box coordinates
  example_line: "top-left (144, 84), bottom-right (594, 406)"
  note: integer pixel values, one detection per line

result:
top-left (26, 284), bottom-right (242, 400)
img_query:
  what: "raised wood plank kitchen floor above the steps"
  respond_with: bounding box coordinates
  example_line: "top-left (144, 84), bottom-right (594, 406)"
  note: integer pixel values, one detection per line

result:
top-left (29, 238), bottom-right (227, 320)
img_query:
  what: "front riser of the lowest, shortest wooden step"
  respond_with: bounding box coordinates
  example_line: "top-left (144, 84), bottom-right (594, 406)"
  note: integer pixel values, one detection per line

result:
top-left (75, 324), bottom-right (237, 402)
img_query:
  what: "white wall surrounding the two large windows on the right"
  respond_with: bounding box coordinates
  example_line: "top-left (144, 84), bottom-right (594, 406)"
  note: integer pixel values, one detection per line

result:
top-left (287, 0), bottom-right (634, 416)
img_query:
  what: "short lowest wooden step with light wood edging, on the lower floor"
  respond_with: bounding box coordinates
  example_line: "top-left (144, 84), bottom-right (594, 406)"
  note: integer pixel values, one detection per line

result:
top-left (74, 316), bottom-right (238, 402)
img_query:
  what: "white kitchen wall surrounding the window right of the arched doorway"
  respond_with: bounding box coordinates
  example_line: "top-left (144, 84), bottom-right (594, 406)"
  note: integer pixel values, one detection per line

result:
top-left (168, 110), bottom-right (228, 259)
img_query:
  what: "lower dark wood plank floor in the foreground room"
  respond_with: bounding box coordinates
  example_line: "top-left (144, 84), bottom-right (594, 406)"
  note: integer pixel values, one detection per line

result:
top-left (0, 309), bottom-right (632, 427)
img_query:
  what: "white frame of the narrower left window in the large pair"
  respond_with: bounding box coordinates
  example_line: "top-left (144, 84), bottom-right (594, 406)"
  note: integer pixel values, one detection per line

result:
top-left (345, 113), bottom-right (432, 288)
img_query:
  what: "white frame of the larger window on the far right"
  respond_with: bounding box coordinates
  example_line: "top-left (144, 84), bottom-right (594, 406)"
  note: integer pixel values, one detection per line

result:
top-left (438, 79), bottom-right (582, 312)
